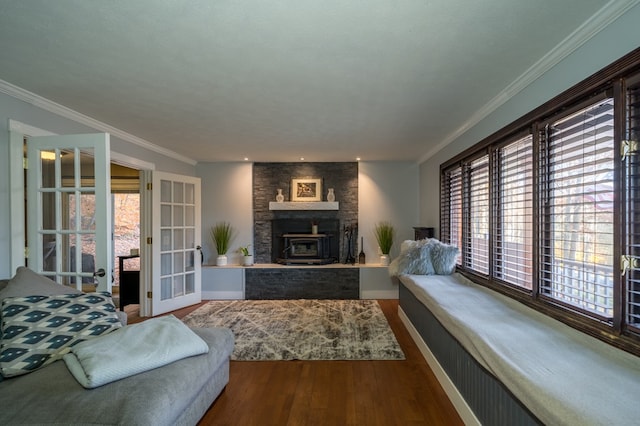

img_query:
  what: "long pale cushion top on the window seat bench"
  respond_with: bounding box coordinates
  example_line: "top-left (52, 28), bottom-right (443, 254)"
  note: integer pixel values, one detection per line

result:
top-left (400, 274), bottom-right (640, 426)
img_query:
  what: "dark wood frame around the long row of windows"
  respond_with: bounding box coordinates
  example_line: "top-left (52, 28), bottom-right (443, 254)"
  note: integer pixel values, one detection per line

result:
top-left (440, 48), bottom-right (640, 355)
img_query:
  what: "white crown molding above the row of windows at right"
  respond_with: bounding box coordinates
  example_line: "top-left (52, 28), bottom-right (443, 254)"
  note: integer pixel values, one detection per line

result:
top-left (418, 0), bottom-right (640, 164)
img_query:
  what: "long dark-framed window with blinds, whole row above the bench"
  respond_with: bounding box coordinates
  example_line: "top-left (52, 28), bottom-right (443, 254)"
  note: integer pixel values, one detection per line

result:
top-left (440, 49), bottom-right (640, 355)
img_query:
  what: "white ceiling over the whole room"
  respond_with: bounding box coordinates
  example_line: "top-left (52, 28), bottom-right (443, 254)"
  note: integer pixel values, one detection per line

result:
top-left (0, 0), bottom-right (630, 161)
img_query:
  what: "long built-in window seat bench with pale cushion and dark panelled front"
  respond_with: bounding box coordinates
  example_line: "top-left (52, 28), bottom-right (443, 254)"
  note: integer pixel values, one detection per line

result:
top-left (399, 274), bottom-right (640, 425)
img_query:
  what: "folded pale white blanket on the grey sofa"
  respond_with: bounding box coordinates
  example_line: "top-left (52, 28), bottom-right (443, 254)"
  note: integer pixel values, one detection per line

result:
top-left (63, 315), bottom-right (209, 389)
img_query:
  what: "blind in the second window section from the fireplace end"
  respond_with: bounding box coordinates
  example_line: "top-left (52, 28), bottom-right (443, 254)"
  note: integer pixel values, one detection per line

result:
top-left (462, 155), bottom-right (490, 275)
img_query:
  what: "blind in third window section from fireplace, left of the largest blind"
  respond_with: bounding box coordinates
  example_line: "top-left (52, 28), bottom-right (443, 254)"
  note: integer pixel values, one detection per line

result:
top-left (493, 135), bottom-right (533, 289)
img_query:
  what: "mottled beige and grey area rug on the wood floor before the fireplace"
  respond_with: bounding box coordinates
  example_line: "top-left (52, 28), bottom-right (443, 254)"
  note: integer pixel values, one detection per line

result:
top-left (183, 300), bottom-right (404, 361)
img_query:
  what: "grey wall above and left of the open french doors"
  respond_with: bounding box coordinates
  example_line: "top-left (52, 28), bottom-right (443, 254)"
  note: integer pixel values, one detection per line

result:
top-left (0, 93), bottom-right (195, 278)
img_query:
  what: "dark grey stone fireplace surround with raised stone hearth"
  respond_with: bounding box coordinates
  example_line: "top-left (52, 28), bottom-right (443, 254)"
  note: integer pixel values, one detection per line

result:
top-left (249, 162), bottom-right (360, 299)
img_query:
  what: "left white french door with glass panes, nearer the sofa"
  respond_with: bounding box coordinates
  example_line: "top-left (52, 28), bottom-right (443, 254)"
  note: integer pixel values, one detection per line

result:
top-left (27, 133), bottom-right (113, 292)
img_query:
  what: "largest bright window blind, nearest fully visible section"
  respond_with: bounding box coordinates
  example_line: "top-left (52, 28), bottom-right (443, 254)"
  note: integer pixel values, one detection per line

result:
top-left (540, 98), bottom-right (614, 318)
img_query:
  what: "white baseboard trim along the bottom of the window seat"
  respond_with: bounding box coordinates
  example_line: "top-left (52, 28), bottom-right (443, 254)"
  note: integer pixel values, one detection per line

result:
top-left (398, 306), bottom-right (482, 426)
